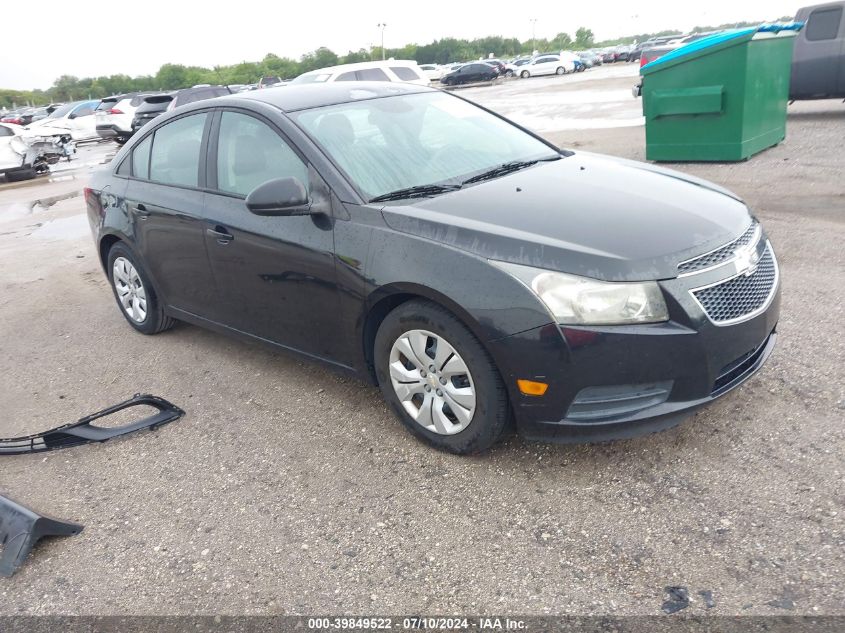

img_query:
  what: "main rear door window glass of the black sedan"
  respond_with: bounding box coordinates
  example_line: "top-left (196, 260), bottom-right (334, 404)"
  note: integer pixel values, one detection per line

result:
top-left (150, 112), bottom-right (208, 187)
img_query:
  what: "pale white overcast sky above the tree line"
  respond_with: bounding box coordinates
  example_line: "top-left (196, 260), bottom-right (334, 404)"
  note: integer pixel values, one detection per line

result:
top-left (0, 0), bottom-right (800, 90)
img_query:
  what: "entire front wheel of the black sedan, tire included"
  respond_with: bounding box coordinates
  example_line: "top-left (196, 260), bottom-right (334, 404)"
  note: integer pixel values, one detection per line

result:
top-left (374, 300), bottom-right (510, 455)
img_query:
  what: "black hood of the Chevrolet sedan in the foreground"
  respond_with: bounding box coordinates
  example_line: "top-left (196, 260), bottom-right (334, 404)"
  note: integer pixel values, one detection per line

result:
top-left (382, 152), bottom-right (751, 281)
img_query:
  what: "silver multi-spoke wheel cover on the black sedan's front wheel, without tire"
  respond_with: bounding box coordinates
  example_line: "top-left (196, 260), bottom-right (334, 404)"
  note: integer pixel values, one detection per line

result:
top-left (389, 330), bottom-right (476, 435)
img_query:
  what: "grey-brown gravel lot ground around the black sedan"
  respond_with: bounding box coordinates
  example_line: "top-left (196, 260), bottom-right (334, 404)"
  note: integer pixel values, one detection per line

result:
top-left (0, 65), bottom-right (845, 614)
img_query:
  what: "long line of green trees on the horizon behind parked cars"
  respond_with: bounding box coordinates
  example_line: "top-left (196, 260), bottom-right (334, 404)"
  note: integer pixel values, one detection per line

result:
top-left (0, 18), bottom-right (790, 107)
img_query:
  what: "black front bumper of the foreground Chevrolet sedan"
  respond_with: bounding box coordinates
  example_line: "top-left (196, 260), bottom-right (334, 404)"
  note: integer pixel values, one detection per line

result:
top-left (488, 236), bottom-right (780, 443)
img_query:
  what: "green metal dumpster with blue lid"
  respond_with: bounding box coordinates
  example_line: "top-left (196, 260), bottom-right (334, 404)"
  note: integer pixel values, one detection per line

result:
top-left (640, 23), bottom-right (802, 161)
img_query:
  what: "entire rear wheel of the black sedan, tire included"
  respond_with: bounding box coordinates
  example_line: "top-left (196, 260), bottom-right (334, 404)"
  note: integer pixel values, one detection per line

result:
top-left (107, 242), bottom-right (176, 334)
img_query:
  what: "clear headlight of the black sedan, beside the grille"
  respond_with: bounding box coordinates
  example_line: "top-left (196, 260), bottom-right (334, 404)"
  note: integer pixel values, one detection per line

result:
top-left (490, 260), bottom-right (669, 325)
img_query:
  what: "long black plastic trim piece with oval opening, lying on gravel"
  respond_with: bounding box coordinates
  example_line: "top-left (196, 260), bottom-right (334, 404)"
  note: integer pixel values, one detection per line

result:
top-left (0, 394), bottom-right (185, 456)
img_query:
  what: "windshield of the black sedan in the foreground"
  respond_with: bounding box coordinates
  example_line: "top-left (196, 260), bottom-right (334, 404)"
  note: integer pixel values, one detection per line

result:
top-left (292, 92), bottom-right (558, 200)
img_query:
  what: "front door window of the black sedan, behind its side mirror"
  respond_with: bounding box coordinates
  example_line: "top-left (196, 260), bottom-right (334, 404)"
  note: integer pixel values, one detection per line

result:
top-left (217, 112), bottom-right (308, 196)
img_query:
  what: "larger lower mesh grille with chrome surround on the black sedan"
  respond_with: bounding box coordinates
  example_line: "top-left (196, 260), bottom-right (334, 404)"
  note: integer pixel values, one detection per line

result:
top-left (691, 245), bottom-right (778, 325)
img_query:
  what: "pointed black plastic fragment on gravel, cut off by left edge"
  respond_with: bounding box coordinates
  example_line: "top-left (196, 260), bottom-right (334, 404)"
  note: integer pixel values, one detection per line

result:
top-left (0, 495), bottom-right (82, 578)
